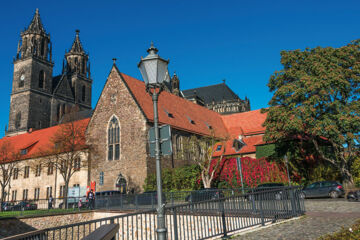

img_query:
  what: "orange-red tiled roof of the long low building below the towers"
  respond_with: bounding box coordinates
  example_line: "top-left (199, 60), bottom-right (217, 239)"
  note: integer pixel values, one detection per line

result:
top-left (0, 118), bottom-right (90, 159)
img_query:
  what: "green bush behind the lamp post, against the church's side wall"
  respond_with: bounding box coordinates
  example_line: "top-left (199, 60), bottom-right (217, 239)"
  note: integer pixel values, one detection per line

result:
top-left (143, 164), bottom-right (201, 192)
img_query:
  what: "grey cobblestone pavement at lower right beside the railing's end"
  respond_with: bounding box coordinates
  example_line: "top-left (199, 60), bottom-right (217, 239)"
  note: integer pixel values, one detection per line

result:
top-left (233, 199), bottom-right (360, 240)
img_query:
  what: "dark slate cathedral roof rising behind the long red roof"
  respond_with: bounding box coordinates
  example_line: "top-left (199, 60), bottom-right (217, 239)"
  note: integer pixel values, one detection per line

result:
top-left (182, 83), bottom-right (240, 104)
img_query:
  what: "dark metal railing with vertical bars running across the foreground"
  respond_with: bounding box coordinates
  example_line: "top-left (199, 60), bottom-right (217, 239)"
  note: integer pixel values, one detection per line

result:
top-left (4, 187), bottom-right (305, 240)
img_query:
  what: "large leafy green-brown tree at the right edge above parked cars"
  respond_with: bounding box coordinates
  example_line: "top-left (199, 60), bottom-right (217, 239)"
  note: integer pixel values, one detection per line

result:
top-left (264, 40), bottom-right (360, 184)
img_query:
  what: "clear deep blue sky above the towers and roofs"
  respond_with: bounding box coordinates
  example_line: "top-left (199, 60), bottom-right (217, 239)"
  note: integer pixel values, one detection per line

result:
top-left (0, 0), bottom-right (360, 136)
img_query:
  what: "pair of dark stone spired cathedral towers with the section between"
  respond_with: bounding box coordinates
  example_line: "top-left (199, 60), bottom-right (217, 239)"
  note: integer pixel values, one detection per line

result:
top-left (5, 9), bottom-right (92, 136)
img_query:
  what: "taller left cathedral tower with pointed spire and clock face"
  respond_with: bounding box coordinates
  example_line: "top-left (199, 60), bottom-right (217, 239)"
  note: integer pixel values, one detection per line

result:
top-left (6, 9), bottom-right (53, 135)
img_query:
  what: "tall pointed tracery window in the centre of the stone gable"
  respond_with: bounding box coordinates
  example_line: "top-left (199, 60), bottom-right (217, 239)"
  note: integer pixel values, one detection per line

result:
top-left (108, 117), bottom-right (120, 161)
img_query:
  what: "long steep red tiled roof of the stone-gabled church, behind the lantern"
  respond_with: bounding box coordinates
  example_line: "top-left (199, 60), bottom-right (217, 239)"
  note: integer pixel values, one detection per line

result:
top-left (120, 73), bottom-right (227, 137)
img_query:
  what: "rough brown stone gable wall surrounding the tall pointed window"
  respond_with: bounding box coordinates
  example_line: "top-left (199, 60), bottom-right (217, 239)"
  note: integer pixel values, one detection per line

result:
top-left (87, 66), bottom-right (149, 191)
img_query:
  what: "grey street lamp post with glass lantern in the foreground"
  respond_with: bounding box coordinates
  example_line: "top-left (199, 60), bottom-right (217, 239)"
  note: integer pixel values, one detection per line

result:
top-left (138, 42), bottom-right (169, 240)
